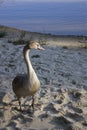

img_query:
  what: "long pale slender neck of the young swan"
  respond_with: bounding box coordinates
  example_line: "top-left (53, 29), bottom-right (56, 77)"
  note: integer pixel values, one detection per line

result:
top-left (23, 46), bottom-right (35, 79)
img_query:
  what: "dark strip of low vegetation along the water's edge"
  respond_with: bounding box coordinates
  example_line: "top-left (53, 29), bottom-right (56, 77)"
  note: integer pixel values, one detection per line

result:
top-left (0, 25), bottom-right (87, 48)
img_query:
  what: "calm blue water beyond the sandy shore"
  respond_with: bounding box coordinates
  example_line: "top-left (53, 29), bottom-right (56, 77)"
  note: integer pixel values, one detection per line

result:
top-left (0, 0), bottom-right (87, 36)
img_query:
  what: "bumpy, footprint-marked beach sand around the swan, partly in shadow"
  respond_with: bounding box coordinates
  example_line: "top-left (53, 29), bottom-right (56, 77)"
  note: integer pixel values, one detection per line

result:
top-left (0, 27), bottom-right (87, 130)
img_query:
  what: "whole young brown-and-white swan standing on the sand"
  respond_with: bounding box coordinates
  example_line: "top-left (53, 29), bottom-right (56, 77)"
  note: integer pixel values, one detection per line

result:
top-left (12, 42), bottom-right (43, 110)
